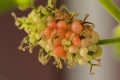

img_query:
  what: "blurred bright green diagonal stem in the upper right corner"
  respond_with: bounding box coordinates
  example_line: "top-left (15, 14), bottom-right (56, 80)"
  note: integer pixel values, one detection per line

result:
top-left (98, 0), bottom-right (120, 23)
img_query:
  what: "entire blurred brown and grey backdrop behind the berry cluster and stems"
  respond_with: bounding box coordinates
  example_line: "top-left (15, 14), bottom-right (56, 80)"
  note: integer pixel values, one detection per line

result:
top-left (0, 0), bottom-right (120, 80)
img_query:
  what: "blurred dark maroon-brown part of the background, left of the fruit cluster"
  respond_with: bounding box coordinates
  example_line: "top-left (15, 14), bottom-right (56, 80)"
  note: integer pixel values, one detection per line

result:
top-left (0, 0), bottom-right (63, 80)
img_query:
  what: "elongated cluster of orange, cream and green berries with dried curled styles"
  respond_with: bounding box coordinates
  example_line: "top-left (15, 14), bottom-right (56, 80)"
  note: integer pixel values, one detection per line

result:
top-left (12, 0), bottom-right (102, 74)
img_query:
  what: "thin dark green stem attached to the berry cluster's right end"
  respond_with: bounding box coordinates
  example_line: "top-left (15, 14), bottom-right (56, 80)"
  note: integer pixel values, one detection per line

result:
top-left (97, 37), bottom-right (120, 45)
